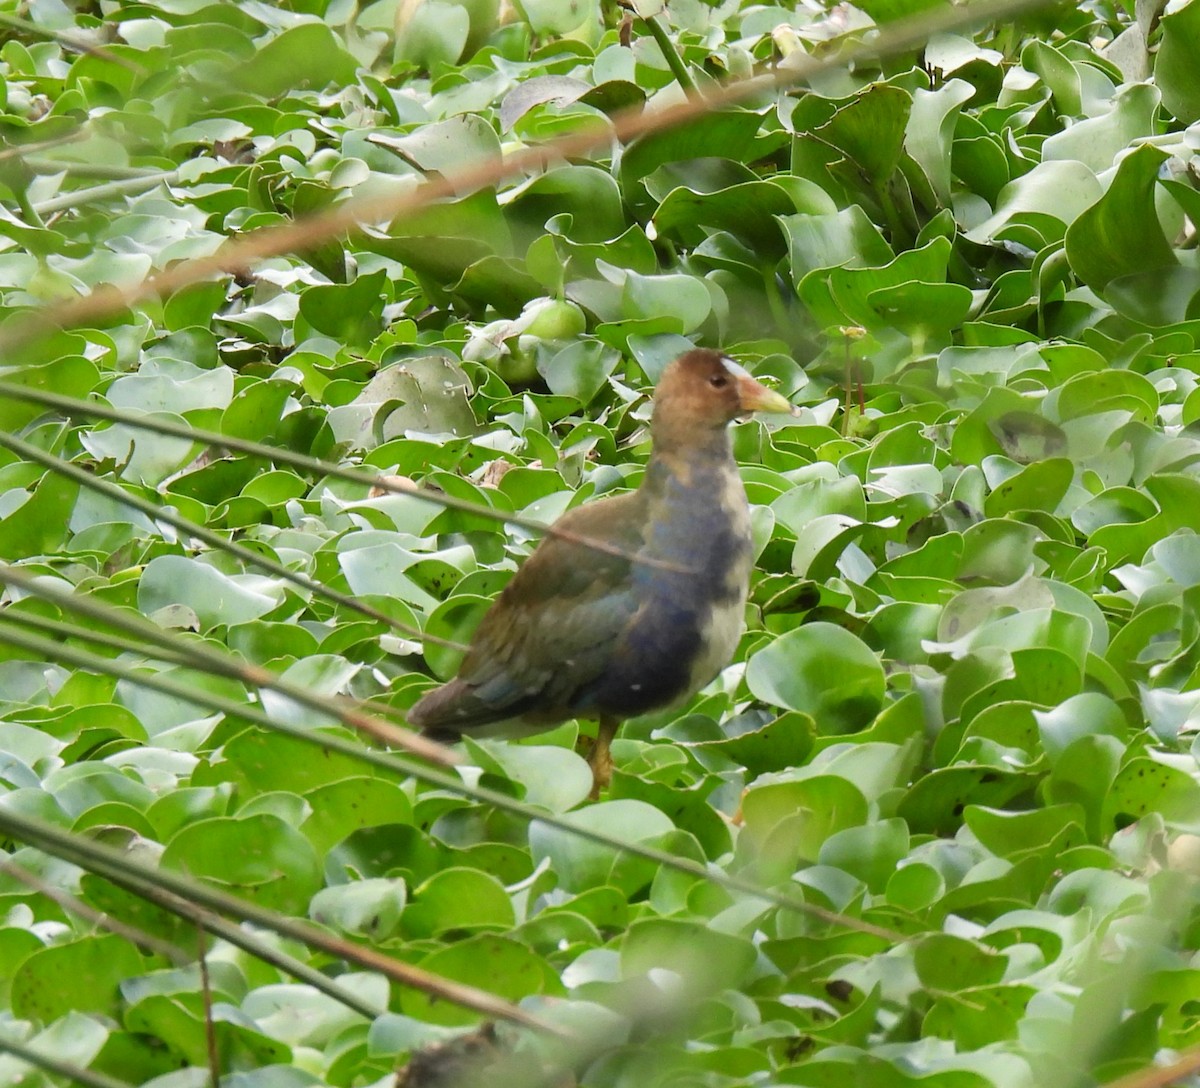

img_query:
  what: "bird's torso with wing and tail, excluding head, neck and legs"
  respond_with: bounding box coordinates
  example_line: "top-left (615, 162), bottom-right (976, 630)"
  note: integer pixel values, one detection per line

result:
top-left (409, 462), bottom-right (750, 735)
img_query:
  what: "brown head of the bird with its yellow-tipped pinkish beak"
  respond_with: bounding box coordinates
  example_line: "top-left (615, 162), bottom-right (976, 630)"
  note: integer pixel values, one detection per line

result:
top-left (652, 348), bottom-right (793, 445)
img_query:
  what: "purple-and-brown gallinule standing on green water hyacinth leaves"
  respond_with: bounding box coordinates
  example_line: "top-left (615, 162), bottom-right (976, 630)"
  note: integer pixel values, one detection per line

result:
top-left (407, 348), bottom-right (796, 799)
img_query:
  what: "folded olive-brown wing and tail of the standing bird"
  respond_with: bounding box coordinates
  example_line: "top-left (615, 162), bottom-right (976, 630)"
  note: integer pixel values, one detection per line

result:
top-left (410, 492), bottom-right (644, 731)
